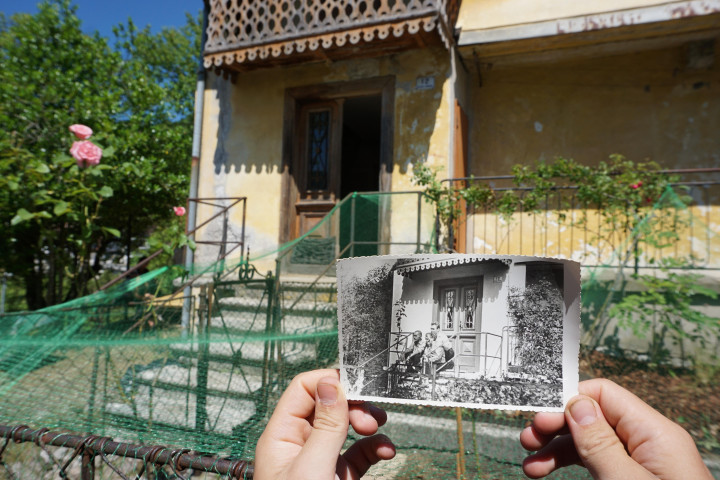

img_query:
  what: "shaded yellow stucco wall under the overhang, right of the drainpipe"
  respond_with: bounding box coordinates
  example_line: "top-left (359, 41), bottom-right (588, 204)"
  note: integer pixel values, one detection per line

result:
top-left (467, 42), bottom-right (720, 175)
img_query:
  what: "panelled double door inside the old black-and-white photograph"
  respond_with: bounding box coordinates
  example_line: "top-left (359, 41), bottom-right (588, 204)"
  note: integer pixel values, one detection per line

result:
top-left (438, 281), bottom-right (482, 373)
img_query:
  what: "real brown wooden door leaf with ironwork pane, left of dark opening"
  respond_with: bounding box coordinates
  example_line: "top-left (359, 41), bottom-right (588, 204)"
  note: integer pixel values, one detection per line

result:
top-left (291, 100), bottom-right (342, 238)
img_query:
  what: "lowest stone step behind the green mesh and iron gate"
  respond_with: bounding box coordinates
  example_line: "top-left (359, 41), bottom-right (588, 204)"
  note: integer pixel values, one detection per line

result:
top-left (105, 385), bottom-right (256, 435)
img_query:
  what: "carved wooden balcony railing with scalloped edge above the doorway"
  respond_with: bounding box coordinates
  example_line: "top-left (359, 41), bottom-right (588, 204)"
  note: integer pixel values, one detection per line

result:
top-left (204, 0), bottom-right (460, 69)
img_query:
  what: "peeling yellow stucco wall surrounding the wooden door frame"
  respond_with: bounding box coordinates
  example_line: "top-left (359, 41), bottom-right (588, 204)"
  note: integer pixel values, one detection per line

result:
top-left (198, 48), bottom-right (452, 266)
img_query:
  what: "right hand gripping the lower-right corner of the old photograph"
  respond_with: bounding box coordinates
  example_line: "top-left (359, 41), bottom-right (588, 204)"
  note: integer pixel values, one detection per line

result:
top-left (520, 379), bottom-right (713, 480)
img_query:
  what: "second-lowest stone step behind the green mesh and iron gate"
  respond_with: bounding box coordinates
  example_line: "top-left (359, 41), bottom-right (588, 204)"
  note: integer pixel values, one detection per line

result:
top-left (135, 365), bottom-right (262, 398)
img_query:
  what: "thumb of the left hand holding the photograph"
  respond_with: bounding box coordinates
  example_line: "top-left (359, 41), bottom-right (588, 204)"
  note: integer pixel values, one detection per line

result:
top-left (299, 377), bottom-right (349, 478)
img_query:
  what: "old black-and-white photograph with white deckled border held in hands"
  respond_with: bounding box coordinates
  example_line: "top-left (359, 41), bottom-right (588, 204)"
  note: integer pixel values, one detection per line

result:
top-left (337, 254), bottom-right (580, 411)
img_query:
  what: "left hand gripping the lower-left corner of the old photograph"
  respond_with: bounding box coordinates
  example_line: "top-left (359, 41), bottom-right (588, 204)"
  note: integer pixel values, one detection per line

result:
top-left (254, 370), bottom-right (395, 480)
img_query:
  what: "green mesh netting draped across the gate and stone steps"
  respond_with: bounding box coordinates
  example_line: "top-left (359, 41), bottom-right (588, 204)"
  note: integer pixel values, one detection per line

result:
top-left (0, 193), bottom-right (716, 479)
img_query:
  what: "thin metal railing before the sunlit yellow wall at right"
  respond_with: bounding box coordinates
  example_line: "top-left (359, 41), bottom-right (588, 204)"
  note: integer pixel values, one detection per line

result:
top-left (443, 168), bottom-right (720, 270)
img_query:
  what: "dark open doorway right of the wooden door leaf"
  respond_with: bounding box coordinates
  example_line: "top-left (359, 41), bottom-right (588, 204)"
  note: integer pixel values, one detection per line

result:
top-left (339, 95), bottom-right (382, 257)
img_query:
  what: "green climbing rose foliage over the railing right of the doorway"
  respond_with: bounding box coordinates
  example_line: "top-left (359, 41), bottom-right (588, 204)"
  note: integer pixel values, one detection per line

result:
top-left (413, 155), bottom-right (720, 365)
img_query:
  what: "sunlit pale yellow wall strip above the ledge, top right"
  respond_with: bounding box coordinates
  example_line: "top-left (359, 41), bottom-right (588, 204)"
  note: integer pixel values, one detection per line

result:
top-left (457, 0), bottom-right (688, 31)
